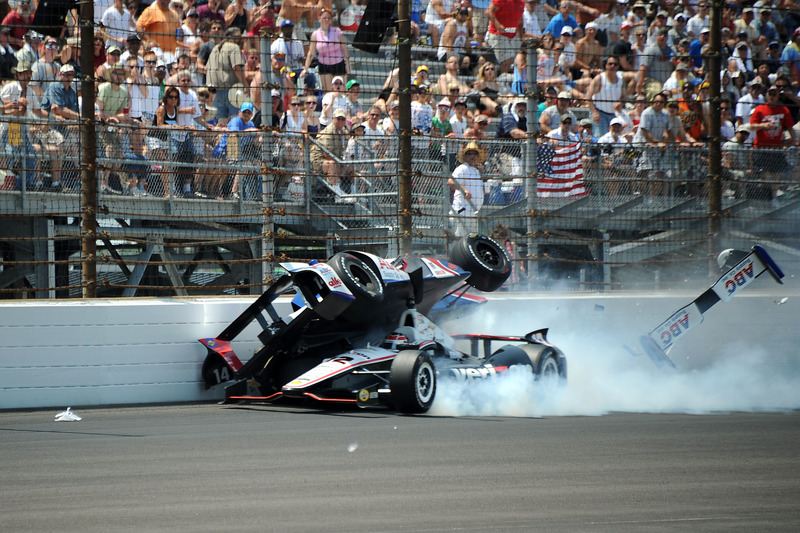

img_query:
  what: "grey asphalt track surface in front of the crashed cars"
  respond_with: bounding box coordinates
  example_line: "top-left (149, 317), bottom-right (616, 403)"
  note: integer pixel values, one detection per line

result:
top-left (0, 405), bottom-right (800, 532)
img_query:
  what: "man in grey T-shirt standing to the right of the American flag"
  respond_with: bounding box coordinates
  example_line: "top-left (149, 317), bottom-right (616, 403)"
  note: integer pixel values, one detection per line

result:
top-left (633, 92), bottom-right (671, 197)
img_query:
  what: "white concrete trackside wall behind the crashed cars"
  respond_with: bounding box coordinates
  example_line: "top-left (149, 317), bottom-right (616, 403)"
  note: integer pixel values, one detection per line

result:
top-left (0, 288), bottom-right (800, 409)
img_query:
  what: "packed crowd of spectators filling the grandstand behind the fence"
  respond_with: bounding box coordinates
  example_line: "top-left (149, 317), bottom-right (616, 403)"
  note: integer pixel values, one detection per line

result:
top-left (0, 0), bottom-right (800, 202)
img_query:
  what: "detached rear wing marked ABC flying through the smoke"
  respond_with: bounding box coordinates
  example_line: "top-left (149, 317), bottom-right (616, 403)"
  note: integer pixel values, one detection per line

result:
top-left (639, 245), bottom-right (784, 368)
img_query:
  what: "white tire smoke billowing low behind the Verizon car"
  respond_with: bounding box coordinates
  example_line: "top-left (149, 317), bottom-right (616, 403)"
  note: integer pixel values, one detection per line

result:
top-left (431, 300), bottom-right (800, 417)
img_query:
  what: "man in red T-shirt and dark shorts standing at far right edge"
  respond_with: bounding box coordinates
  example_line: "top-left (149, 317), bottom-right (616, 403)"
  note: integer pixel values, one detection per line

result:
top-left (750, 85), bottom-right (800, 200)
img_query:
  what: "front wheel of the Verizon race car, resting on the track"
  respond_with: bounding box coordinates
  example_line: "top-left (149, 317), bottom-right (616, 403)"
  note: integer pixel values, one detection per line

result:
top-left (389, 350), bottom-right (436, 413)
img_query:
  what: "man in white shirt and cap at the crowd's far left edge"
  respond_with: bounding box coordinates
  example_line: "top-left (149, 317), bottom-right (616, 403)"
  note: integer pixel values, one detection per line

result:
top-left (0, 61), bottom-right (47, 187)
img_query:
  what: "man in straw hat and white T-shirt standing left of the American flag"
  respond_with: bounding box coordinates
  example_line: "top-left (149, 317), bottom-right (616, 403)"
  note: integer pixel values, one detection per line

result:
top-left (447, 141), bottom-right (486, 237)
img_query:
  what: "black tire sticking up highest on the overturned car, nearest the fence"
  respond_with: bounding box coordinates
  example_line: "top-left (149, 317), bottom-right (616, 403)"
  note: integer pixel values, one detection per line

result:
top-left (450, 233), bottom-right (511, 292)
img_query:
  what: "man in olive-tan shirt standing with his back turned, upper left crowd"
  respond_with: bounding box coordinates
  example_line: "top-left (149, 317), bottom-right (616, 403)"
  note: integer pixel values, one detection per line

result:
top-left (206, 28), bottom-right (245, 119)
